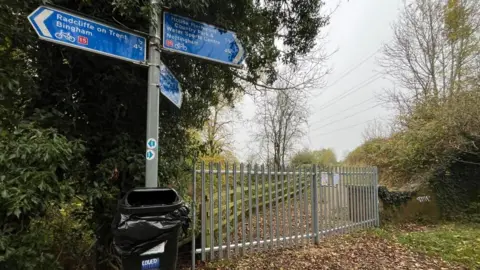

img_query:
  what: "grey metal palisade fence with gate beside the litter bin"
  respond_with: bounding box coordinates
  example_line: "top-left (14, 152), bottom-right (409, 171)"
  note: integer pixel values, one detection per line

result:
top-left (192, 163), bottom-right (379, 268)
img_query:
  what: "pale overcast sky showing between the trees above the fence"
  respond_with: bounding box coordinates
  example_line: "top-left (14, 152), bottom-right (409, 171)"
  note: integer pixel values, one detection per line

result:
top-left (233, 0), bottom-right (402, 161)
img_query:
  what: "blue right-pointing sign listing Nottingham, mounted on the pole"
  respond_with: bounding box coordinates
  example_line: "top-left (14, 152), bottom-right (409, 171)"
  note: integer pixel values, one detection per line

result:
top-left (162, 12), bottom-right (245, 66)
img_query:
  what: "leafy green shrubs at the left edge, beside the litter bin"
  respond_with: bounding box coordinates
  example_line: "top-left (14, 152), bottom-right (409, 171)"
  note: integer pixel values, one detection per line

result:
top-left (0, 124), bottom-right (93, 269)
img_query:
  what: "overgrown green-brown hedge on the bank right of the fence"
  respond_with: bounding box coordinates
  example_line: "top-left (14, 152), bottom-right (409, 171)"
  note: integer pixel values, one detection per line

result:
top-left (347, 89), bottom-right (480, 219)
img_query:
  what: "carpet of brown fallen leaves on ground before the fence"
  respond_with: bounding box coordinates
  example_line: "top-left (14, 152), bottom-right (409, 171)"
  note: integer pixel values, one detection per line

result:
top-left (197, 232), bottom-right (466, 270)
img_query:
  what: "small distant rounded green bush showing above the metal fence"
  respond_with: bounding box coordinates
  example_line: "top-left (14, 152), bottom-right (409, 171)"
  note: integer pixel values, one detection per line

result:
top-left (290, 148), bottom-right (337, 166)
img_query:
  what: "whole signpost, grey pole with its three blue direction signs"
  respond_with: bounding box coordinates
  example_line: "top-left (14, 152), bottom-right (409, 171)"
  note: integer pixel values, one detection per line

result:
top-left (28, 4), bottom-right (246, 194)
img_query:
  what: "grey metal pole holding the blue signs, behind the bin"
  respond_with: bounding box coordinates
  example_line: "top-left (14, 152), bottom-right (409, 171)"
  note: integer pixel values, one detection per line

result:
top-left (145, 0), bottom-right (161, 187)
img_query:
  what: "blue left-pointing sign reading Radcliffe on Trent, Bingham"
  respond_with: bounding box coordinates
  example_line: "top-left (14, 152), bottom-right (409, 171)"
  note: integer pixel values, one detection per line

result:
top-left (28, 6), bottom-right (147, 64)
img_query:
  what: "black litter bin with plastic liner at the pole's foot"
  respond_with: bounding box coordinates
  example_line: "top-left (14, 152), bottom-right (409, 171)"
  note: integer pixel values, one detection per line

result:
top-left (112, 188), bottom-right (189, 270)
